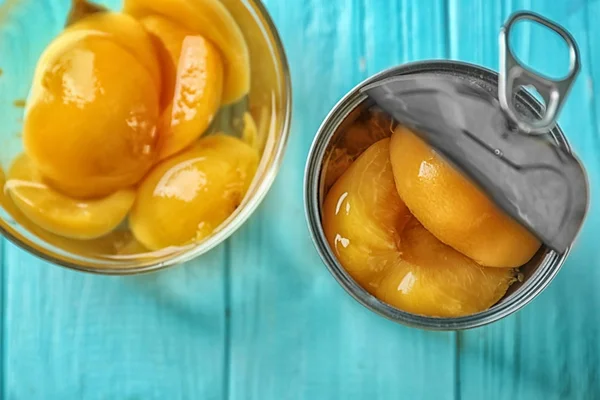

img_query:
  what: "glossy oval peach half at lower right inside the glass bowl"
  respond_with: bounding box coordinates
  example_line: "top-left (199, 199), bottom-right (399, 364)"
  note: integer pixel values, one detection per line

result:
top-left (129, 135), bottom-right (258, 250)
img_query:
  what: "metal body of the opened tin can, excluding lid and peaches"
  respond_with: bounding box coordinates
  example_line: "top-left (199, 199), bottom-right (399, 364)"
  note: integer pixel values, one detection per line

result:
top-left (304, 57), bottom-right (571, 330)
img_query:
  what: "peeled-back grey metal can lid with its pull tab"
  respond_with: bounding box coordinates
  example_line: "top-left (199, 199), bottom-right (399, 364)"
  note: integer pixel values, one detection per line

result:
top-left (362, 13), bottom-right (588, 253)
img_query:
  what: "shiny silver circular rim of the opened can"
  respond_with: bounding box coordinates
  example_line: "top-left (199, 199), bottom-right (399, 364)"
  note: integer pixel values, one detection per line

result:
top-left (304, 60), bottom-right (571, 331)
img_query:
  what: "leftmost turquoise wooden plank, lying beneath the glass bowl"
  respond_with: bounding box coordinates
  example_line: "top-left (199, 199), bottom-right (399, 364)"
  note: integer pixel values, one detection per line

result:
top-left (0, 0), bottom-right (227, 400)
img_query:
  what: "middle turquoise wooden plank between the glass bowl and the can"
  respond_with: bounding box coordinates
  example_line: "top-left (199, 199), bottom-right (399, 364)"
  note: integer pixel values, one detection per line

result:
top-left (229, 0), bottom-right (455, 400)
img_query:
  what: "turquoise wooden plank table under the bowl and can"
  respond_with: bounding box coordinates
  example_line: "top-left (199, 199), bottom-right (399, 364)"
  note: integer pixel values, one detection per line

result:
top-left (0, 0), bottom-right (600, 400)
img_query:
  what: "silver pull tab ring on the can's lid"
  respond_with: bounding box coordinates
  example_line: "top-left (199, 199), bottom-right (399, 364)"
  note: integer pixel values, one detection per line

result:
top-left (498, 11), bottom-right (580, 135)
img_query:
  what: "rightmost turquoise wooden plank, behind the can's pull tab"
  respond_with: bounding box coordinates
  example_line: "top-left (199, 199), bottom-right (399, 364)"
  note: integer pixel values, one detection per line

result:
top-left (450, 0), bottom-right (600, 399)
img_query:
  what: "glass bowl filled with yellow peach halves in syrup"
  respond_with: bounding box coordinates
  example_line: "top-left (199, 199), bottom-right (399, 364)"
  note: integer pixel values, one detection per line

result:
top-left (0, 0), bottom-right (291, 274)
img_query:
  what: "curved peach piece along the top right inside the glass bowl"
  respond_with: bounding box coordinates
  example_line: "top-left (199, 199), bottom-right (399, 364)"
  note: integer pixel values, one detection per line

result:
top-left (124, 0), bottom-right (250, 104)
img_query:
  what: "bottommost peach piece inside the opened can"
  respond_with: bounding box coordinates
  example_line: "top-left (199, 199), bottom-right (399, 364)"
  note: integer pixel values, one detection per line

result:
top-left (375, 218), bottom-right (515, 317)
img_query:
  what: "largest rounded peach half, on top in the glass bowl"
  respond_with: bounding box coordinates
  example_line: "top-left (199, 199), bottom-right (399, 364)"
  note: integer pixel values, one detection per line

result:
top-left (23, 30), bottom-right (159, 197)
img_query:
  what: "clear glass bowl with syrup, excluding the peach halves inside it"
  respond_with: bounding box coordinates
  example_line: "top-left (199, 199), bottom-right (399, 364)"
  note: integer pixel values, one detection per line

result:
top-left (0, 0), bottom-right (291, 275)
